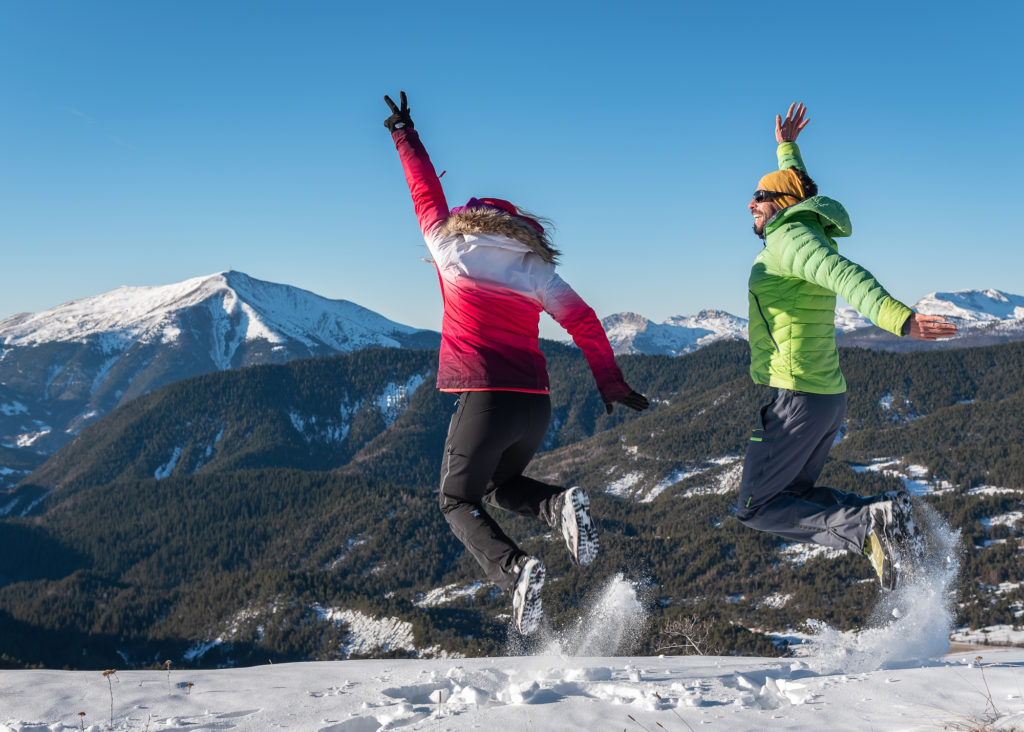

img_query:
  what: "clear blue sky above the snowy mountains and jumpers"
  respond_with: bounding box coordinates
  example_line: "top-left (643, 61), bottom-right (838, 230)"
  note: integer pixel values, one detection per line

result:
top-left (0, 0), bottom-right (1024, 336)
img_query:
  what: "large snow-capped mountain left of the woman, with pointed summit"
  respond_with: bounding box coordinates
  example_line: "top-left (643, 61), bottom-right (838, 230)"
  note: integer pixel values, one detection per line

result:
top-left (0, 271), bottom-right (439, 477)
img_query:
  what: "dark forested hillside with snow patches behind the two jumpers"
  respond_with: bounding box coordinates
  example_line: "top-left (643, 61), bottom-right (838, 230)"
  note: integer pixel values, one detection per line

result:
top-left (0, 342), bottom-right (1024, 668)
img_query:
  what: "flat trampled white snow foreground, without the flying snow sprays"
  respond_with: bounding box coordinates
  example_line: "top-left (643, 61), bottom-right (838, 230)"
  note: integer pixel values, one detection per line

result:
top-left (0, 649), bottom-right (1024, 732)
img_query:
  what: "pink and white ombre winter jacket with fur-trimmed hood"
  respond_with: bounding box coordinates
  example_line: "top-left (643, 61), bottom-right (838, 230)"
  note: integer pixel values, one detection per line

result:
top-left (391, 127), bottom-right (632, 402)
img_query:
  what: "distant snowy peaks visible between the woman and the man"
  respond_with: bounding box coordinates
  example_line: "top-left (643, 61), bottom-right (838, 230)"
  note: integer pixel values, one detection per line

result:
top-left (601, 310), bottom-right (746, 356)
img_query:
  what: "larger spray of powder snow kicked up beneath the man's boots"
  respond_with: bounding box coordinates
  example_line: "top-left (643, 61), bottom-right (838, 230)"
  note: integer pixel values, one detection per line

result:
top-left (801, 502), bottom-right (961, 674)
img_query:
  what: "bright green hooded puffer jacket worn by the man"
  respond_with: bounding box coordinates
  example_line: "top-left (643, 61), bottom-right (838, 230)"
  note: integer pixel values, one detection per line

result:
top-left (749, 142), bottom-right (913, 394)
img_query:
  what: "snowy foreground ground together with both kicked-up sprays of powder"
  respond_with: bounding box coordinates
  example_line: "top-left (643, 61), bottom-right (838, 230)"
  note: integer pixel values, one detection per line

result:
top-left (0, 495), bottom-right (1024, 732)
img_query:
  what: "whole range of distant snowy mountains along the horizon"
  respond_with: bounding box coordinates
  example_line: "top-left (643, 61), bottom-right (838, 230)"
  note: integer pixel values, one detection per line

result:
top-left (0, 271), bottom-right (1024, 488)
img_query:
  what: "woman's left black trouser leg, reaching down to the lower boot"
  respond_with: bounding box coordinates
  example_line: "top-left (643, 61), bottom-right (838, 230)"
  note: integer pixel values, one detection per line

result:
top-left (439, 391), bottom-right (548, 589)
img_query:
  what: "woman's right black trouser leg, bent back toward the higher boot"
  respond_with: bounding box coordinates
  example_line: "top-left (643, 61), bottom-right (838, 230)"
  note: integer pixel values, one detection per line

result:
top-left (485, 394), bottom-right (565, 524)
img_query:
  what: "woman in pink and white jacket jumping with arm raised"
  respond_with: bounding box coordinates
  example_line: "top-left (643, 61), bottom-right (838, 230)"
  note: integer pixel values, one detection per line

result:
top-left (384, 92), bottom-right (648, 635)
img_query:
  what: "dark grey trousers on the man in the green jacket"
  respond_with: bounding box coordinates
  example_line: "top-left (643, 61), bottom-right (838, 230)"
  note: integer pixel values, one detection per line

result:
top-left (736, 389), bottom-right (879, 553)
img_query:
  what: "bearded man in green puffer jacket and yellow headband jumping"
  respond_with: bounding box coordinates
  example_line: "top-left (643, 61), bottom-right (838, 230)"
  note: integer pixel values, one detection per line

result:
top-left (736, 104), bottom-right (956, 590)
